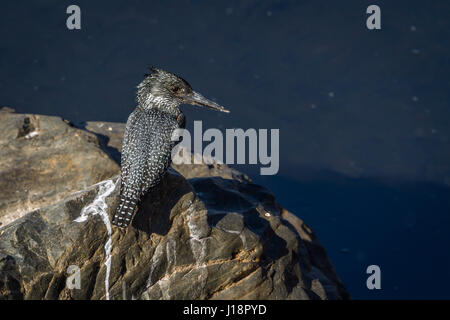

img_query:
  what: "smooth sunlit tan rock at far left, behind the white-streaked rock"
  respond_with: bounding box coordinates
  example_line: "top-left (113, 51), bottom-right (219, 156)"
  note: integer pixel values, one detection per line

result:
top-left (0, 108), bottom-right (120, 225)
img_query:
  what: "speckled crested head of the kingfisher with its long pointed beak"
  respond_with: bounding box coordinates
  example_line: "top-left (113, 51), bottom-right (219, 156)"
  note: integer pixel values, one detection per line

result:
top-left (137, 67), bottom-right (230, 112)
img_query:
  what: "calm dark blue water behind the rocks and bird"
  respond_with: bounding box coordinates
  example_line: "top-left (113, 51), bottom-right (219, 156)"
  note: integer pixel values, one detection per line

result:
top-left (0, 1), bottom-right (450, 299)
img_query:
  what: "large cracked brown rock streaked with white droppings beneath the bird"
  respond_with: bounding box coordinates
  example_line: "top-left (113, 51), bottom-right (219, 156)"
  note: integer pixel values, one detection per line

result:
top-left (0, 110), bottom-right (348, 299)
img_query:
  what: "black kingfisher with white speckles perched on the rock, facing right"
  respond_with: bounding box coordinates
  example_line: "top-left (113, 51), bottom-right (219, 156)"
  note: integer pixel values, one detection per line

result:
top-left (112, 67), bottom-right (230, 228)
